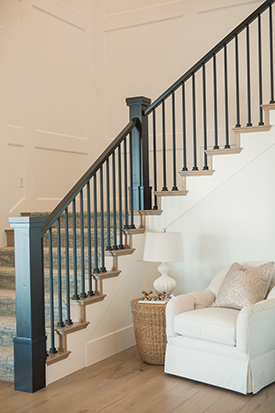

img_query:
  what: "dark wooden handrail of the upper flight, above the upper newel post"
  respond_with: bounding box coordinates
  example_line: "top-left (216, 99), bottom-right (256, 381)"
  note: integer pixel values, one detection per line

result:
top-left (144, 0), bottom-right (275, 115)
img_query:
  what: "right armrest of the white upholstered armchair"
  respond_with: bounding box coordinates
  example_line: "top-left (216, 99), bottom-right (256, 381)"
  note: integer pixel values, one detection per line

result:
top-left (236, 298), bottom-right (275, 358)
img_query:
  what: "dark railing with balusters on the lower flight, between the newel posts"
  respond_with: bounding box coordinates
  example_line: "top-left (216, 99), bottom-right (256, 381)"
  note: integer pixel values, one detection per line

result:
top-left (42, 118), bottom-right (144, 354)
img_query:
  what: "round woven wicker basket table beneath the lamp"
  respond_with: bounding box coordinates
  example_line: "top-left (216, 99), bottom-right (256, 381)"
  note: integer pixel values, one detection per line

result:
top-left (131, 298), bottom-right (166, 365)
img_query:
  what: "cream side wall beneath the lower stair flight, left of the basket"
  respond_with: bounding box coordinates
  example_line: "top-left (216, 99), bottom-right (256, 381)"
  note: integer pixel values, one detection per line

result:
top-left (46, 229), bottom-right (153, 385)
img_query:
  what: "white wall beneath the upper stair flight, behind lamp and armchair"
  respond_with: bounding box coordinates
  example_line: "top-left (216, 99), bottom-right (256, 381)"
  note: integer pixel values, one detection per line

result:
top-left (145, 112), bottom-right (275, 295)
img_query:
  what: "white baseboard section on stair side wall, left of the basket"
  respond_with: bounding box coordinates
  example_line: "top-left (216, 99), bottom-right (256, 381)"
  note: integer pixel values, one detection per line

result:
top-left (86, 325), bottom-right (136, 366)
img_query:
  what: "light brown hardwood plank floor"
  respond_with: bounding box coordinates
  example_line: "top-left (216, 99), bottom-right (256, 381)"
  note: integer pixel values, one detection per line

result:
top-left (0, 347), bottom-right (275, 413)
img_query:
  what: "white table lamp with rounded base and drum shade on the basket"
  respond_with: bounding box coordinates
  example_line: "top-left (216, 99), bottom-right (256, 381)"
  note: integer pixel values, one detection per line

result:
top-left (143, 230), bottom-right (183, 296)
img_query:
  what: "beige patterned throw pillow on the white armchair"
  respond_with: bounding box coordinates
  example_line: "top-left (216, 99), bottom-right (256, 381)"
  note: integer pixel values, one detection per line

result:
top-left (212, 262), bottom-right (274, 310)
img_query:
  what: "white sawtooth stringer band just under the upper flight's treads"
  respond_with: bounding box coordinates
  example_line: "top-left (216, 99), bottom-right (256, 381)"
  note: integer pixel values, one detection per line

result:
top-left (150, 122), bottom-right (275, 231)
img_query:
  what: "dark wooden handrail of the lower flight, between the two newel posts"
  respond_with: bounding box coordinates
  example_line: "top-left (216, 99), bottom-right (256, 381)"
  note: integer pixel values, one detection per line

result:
top-left (41, 118), bottom-right (140, 236)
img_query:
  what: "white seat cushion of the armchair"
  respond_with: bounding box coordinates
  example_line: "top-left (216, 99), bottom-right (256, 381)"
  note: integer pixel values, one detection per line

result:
top-left (174, 308), bottom-right (240, 346)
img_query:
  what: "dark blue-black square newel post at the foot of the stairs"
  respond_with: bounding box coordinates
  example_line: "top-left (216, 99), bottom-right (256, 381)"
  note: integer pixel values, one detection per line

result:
top-left (9, 217), bottom-right (46, 393)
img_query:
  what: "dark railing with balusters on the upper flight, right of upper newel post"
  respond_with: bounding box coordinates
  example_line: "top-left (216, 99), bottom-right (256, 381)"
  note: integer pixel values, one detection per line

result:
top-left (144, 0), bottom-right (274, 205)
